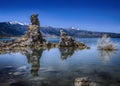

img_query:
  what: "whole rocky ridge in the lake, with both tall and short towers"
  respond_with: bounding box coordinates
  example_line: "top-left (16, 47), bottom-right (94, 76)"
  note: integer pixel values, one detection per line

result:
top-left (0, 14), bottom-right (89, 51)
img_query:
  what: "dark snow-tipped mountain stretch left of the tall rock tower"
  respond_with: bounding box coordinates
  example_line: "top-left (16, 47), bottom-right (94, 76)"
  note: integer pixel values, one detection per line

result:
top-left (0, 22), bottom-right (27, 36)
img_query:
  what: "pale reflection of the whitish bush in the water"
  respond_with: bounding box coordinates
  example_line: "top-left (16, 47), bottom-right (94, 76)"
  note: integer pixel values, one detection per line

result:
top-left (98, 50), bottom-right (117, 64)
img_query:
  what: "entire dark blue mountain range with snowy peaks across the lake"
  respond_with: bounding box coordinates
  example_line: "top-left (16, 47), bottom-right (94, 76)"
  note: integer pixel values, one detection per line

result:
top-left (0, 22), bottom-right (120, 38)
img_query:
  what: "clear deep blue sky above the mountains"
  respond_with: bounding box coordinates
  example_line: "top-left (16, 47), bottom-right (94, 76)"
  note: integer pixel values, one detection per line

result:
top-left (0, 0), bottom-right (120, 33)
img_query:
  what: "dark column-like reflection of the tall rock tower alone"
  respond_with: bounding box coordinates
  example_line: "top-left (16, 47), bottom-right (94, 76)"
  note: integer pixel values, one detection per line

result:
top-left (22, 49), bottom-right (43, 76)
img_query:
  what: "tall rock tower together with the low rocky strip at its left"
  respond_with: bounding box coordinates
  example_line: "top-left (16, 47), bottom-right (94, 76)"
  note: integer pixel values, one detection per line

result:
top-left (0, 14), bottom-right (45, 48)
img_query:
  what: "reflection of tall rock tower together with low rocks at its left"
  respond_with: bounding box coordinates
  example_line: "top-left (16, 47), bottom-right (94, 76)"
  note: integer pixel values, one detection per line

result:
top-left (0, 47), bottom-right (45, 76)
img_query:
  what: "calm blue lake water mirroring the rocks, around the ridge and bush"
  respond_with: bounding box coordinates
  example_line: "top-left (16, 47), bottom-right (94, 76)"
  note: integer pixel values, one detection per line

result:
top-left (0, 38), bottom-right (120, 86)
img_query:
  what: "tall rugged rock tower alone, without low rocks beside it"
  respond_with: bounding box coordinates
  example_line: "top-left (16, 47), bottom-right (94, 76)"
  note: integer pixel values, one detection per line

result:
top-left (19, 14), bottom-right (44, 45)
